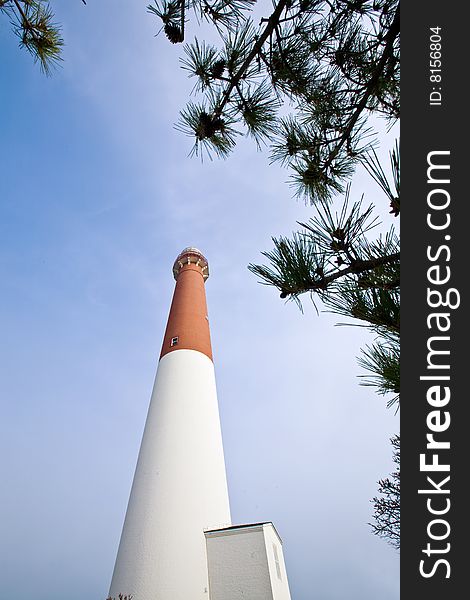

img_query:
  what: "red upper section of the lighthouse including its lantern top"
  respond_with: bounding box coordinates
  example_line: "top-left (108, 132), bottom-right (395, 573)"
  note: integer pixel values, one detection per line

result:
top-left (160, 248), bottom-right (212, 360)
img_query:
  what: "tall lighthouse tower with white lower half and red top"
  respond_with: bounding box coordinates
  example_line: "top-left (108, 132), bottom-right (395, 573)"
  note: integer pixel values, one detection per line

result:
top-left (109, 248), bottom-right (231, 600)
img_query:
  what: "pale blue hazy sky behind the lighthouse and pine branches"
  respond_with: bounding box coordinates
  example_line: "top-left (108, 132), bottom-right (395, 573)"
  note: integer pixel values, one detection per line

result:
top-left (0, 0), bottom-right (399, 600)
